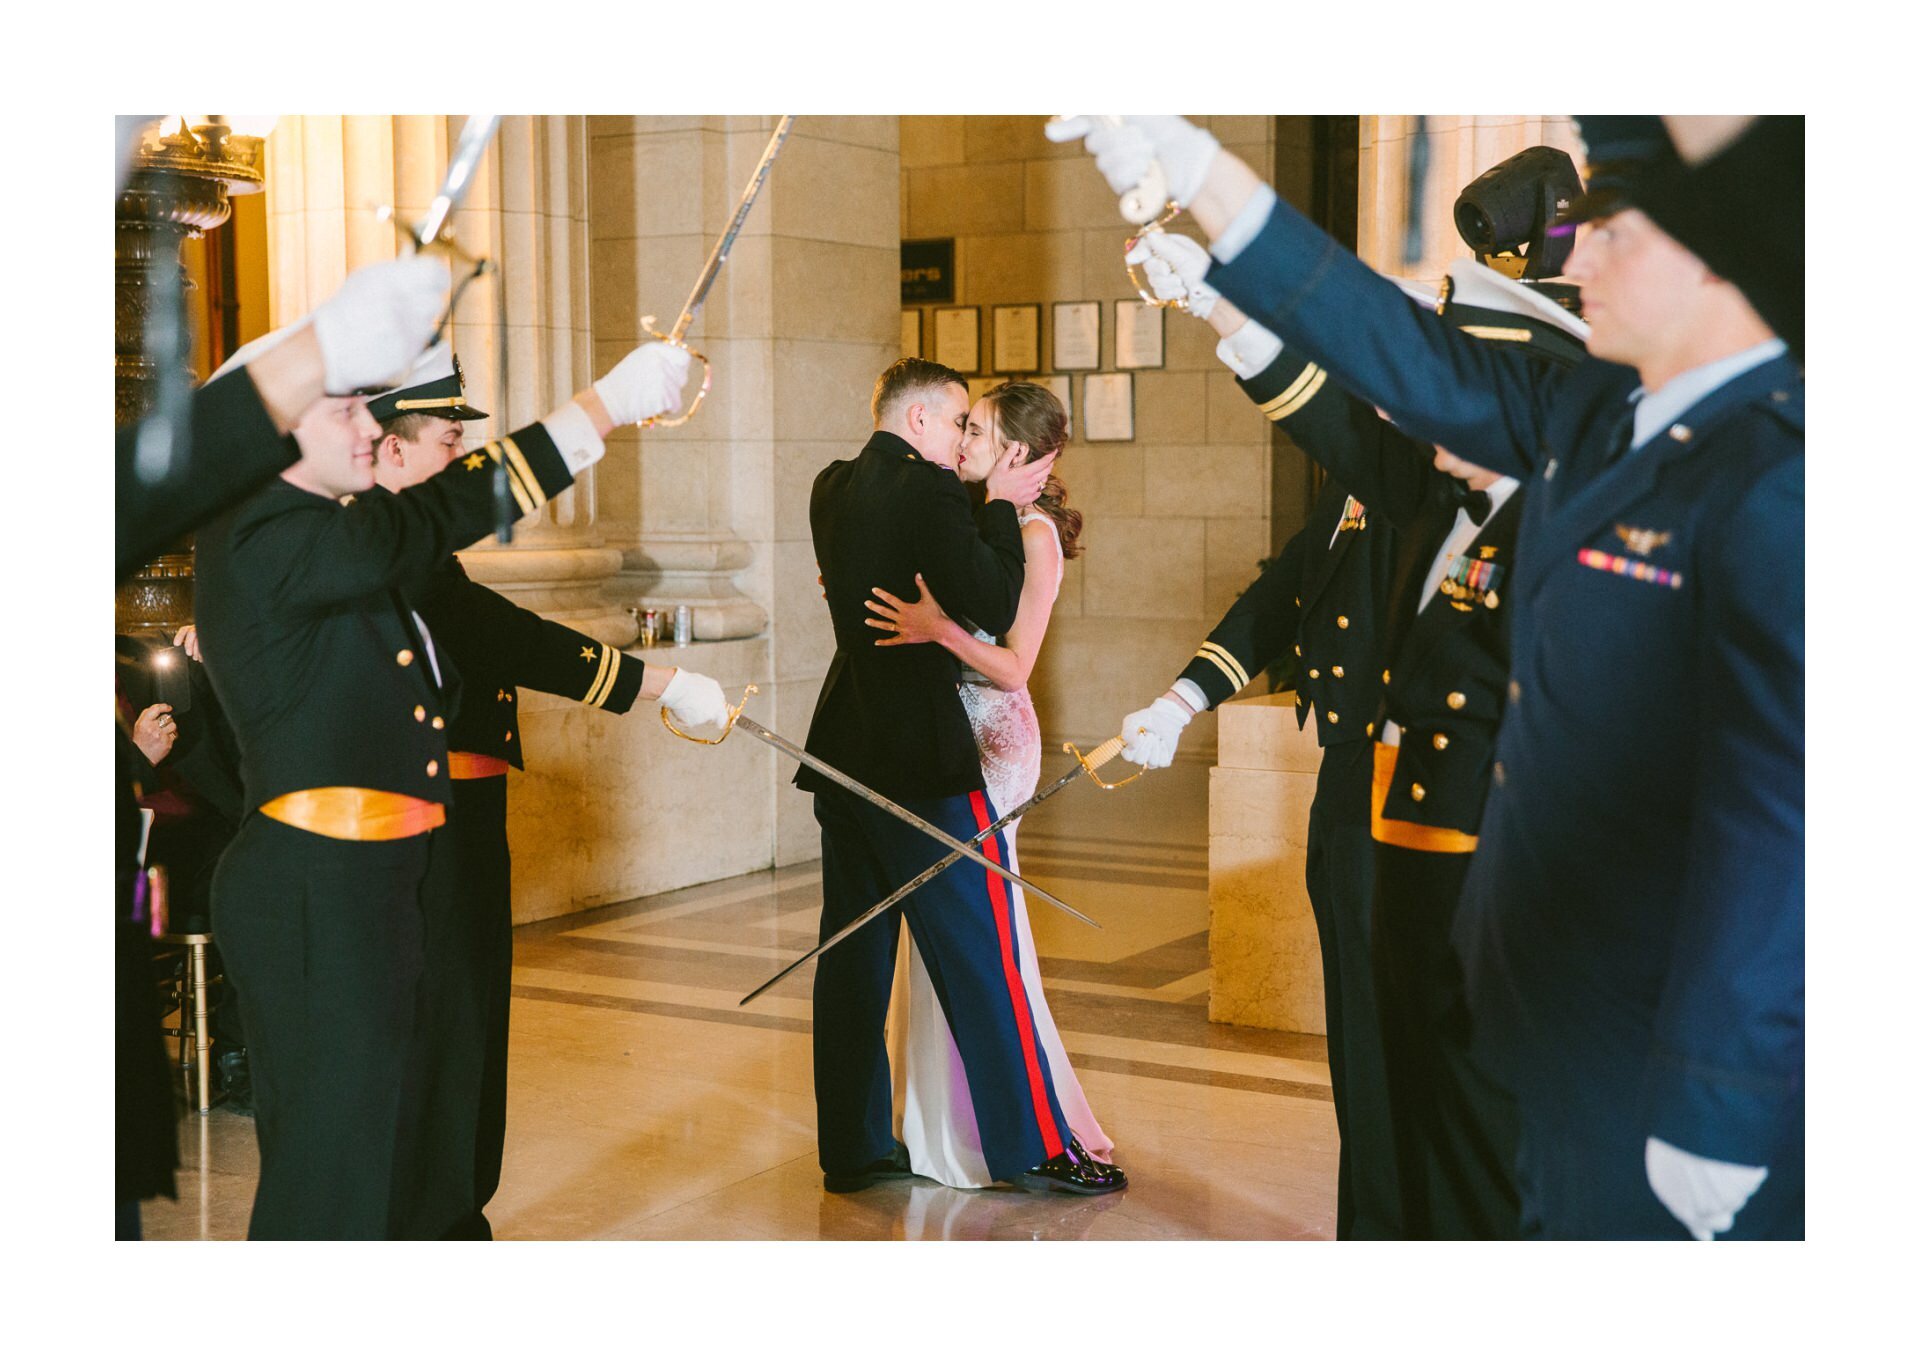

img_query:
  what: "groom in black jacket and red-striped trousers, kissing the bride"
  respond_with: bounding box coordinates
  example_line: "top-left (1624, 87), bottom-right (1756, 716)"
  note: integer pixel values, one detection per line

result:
top-left (795, 357), bottom-right (1127, 1195)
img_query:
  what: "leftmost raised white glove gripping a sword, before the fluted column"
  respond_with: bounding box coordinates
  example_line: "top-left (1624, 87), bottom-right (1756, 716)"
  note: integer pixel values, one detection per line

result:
top-left (313, 254), bottom-right (453, 396)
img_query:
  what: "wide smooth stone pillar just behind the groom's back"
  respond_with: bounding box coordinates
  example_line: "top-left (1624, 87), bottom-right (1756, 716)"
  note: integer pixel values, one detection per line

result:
top-left (589, 117), bottom-right (900, 862)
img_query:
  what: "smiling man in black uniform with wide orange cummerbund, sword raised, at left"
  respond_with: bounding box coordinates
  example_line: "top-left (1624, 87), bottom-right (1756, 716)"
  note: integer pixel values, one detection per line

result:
top-left (196, 318), bottom-right (714, 1239)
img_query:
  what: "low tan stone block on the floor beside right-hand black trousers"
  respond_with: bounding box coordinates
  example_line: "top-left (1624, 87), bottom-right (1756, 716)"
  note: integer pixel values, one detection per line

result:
top-left (1208, 691), bottom-right (1327, 1035)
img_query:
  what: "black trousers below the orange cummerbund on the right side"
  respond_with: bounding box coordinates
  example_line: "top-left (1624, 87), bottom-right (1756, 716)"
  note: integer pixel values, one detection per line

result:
top-left (1373, 843), bottom-right (1521, 1239)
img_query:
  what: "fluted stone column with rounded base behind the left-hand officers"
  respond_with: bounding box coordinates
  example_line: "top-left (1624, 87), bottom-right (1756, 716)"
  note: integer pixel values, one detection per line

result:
top-left (267, 115), bottom-right (636, 645)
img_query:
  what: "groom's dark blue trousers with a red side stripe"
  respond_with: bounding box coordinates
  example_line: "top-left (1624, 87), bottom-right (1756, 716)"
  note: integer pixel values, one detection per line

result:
top-left (814, 787), bottom-right (1071, 1181)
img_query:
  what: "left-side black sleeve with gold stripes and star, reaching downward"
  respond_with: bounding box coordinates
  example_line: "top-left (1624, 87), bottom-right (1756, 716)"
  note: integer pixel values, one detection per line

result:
top-left (420, 561), bottom-right (647, 713)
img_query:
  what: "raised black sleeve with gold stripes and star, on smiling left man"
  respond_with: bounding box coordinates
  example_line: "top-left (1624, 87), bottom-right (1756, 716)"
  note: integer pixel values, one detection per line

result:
top-left (234, 424), bottom-right (574, 609)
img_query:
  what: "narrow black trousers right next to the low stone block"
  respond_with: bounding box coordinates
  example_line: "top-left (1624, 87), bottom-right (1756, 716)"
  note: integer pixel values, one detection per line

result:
top-left (1308, 739), bottom-right (1402, 1239)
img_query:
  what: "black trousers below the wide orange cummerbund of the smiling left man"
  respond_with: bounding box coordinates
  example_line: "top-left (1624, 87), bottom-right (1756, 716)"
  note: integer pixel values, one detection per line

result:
top-left (213, 812), bottom-right (447, 1239)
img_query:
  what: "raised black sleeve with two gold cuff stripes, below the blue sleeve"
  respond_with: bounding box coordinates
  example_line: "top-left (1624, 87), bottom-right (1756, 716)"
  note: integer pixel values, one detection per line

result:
top-left (1240, 348), bottom-right (1452, 526)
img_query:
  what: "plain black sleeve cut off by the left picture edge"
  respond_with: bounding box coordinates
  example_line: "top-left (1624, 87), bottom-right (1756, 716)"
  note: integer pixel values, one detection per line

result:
top-left (113, 369), bottom-right (300, 582)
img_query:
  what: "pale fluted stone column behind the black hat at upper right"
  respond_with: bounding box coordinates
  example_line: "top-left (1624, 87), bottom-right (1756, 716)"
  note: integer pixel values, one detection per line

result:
top-left (1359, 113), bottom-right (1584, 284)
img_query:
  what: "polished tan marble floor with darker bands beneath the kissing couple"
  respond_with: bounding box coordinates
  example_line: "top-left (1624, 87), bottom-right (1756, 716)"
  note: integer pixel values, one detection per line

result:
top-left (144, 755), bottom-right (1338, 1239)
